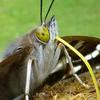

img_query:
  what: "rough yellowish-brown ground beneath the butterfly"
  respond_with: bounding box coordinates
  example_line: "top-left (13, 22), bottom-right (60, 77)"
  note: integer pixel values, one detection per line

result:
top-left (32, 70), bottom-right (100, 100)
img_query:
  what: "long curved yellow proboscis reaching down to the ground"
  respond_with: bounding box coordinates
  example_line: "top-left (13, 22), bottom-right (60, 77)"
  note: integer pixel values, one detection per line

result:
top-left (56, 36), bottom-right (100, 100)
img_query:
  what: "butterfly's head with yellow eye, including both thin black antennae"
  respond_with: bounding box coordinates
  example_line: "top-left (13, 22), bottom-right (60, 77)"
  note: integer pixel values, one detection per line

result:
top-left (34, 0), bottom-right (58, 44)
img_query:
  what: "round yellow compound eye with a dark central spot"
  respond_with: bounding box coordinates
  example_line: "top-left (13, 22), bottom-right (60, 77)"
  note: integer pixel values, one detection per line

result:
top-left (35, 27), bottom-right (50, 43)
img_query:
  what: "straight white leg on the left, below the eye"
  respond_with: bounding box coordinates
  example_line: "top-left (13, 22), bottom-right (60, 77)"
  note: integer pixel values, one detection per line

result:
top-left (13, 57), bottom-right (38, 100)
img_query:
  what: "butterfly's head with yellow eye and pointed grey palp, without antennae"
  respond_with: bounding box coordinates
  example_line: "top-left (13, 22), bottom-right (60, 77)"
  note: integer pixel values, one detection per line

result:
top-left (35, 16), bottom-right (58, 44)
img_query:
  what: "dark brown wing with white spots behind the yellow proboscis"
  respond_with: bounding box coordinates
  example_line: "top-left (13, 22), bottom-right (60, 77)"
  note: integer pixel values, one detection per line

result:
top-left (62, 36), bottom-right (100, 72)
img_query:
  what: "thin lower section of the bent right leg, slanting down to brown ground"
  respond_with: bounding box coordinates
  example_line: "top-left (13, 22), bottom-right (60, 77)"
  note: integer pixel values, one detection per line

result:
top-left (63, 45), bottom-right (89, 88)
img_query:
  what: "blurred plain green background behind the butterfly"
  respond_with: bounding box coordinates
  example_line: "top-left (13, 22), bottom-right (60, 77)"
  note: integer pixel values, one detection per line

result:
top-left (0, 0), bottom-right (100, 52)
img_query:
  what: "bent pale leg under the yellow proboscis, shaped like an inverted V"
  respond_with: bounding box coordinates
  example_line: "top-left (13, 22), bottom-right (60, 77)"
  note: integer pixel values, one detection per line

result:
top-left (51, 43), bottom-right (89, 88)
